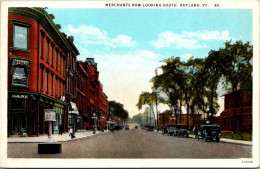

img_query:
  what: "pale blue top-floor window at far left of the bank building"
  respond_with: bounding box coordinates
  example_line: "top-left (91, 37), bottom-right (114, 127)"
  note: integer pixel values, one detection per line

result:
top-left (14, 25), bottom-right (28, 50)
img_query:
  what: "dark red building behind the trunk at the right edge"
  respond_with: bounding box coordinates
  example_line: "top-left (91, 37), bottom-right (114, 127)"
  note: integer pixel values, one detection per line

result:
top-left (216, 91), bottom-right (252, 132)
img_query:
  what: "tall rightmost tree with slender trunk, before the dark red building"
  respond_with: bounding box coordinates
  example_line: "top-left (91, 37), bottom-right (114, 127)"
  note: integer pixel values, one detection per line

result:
top-left (220, 41), bottom-right (253, 131)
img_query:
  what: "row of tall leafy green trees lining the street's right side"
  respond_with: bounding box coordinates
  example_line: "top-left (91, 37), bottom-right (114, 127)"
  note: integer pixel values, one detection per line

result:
top-left (137, 41), bottom-right (253, 125)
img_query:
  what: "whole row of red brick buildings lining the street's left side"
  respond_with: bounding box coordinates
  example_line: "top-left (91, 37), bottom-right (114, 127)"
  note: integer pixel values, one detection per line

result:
top-left (7, 8), bottom-right (107, 136)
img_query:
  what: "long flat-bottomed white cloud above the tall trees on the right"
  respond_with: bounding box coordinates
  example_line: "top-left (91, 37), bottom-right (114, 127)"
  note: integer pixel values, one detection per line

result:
top-left (150, 30), bottom-right (234, 49)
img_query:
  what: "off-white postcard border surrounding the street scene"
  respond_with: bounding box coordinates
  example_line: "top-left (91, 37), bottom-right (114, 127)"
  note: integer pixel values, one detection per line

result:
top-left (0, 0), bottom-right (260, 168)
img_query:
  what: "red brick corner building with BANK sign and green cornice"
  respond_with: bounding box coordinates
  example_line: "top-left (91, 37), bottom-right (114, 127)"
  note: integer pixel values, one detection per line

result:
top-left (8, 8), bottom-right (71, 135)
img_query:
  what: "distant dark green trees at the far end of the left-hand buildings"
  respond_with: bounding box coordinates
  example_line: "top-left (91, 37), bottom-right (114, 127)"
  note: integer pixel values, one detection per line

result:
top-left (108, 101), bottom-right (129, 122)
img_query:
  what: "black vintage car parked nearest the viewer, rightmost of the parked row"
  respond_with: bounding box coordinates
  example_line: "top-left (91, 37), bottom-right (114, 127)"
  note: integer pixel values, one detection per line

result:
top-left (197, 124), bottom-right (221, 142)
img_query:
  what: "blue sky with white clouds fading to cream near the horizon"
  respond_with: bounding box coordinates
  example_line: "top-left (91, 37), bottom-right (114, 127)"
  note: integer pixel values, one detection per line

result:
top-left (47, 8), bottom-right (252, 117)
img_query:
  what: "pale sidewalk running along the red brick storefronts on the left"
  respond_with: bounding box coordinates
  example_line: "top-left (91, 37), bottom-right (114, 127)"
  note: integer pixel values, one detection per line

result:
top-left (7, 130), bottom-right (109, 143)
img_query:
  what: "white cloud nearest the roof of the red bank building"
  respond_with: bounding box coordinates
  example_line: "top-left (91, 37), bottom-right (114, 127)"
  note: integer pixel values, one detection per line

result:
top-left (66, 25), bottom-right (136, 48)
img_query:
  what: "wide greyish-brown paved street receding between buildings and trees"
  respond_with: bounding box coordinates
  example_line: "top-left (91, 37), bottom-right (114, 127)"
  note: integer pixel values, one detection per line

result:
top-left (7, 126), bottom-right (252, 159)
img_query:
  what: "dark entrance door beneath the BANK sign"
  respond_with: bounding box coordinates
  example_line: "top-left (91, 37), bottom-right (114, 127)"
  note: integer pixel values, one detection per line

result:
top-left (12, 114), bottom-right (27, 134)
